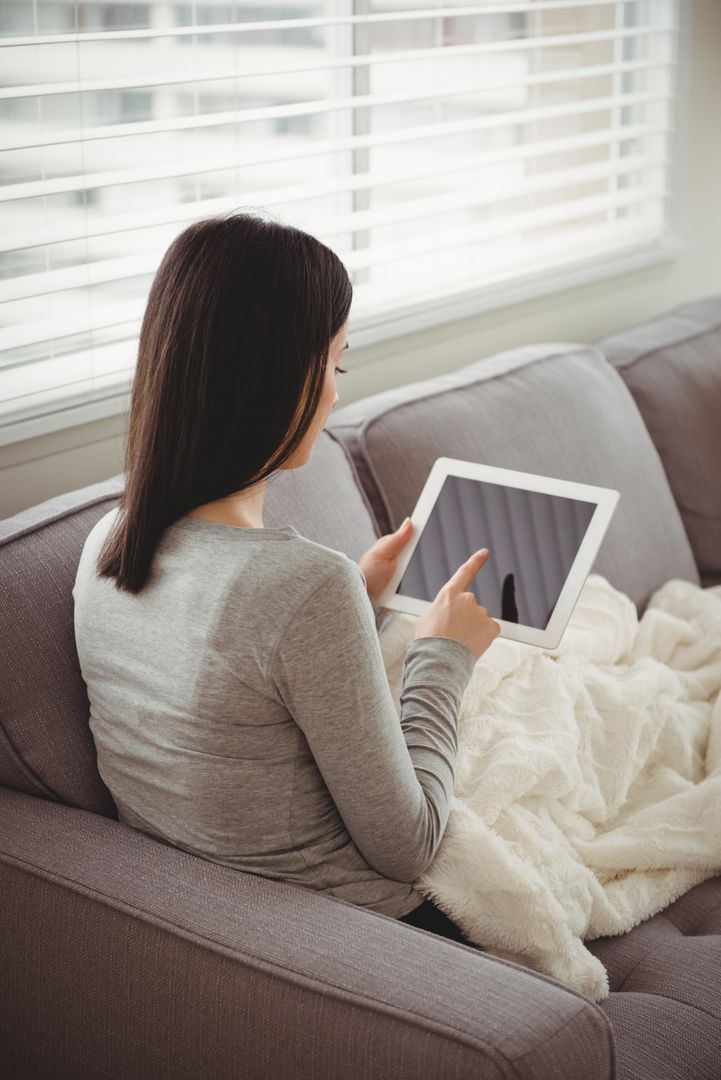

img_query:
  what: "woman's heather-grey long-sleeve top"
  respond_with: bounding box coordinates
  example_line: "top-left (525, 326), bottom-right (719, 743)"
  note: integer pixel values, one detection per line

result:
top-left (72, 508), bottom-right (475, 918)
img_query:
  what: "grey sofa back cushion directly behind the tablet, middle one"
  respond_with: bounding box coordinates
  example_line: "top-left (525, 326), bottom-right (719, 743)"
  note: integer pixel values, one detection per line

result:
top-left (328, 342), bottom-right (699, 615)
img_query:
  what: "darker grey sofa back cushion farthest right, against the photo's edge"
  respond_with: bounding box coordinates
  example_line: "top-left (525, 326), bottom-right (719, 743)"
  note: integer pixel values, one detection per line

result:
top-left (598, 296), bottom-right (721, 584)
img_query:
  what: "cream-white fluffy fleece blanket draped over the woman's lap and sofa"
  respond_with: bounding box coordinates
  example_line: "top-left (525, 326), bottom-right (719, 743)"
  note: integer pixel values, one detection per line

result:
top-left (380, 573), bottom-right (721, 1001)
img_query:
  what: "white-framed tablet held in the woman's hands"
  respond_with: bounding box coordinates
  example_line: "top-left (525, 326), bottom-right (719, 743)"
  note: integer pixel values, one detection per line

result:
top-left (377, 458), bottom-right (621, 649)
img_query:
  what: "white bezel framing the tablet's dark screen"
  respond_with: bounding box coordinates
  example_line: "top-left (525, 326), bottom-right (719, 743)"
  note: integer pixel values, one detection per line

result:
top-left (376, 457), bottom-right (621, 649)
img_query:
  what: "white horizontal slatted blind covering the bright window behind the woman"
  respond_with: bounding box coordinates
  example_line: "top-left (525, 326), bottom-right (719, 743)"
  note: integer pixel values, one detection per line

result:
top-left (0, 0), bottom-right (678, 443)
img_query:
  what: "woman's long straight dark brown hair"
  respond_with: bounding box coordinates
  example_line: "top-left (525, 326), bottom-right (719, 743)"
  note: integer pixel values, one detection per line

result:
top-left (97, 211), bottom-right (353, 593)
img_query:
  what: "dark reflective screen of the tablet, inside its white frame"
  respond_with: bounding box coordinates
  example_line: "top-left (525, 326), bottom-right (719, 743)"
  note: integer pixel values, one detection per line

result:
top-left (396, 476), bottom-right (597, 630)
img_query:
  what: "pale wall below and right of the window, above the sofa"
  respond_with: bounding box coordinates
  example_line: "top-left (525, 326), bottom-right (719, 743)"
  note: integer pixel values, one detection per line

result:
top-left (0, 0), bottom-right (721, 517)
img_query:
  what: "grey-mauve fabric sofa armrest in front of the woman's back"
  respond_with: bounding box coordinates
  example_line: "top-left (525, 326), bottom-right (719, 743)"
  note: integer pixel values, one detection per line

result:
top-left (0, 787), bottom-right (615, 1080)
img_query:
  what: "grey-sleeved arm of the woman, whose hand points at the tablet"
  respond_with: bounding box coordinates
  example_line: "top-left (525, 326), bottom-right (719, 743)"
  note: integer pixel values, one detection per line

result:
top-left (270, 559), bottom-right (476, 882)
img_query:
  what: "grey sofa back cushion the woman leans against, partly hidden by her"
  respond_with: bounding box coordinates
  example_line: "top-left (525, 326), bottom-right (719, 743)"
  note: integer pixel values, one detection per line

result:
top-left (0, 432), bottom-right (377, 818)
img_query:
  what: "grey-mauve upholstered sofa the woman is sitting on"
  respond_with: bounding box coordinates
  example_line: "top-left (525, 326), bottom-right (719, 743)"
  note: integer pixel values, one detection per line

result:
top-left (0, 296), bottom-right (721, 1080)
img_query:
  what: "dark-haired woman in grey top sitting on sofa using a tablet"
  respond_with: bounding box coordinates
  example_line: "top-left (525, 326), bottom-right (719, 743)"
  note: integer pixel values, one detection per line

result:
top-left (73, 214), bottom-right (499, 954)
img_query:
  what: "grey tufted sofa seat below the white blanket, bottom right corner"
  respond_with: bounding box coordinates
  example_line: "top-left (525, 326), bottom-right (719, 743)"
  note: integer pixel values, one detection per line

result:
top-left (585, 877), bottom-right (721, 1080)
